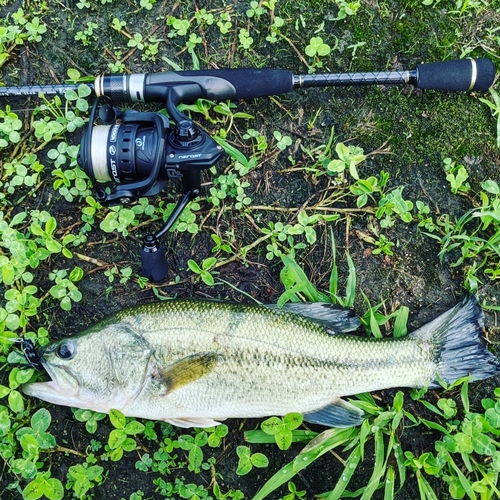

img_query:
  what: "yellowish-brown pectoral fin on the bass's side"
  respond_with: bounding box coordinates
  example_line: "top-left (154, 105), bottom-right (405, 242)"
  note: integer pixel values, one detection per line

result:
top-left (153, 352), bottom-right (219, 395)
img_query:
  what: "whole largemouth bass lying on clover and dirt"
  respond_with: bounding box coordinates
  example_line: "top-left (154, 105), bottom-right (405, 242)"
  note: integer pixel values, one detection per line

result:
top-left (23, 298), bottom-right (500, 427)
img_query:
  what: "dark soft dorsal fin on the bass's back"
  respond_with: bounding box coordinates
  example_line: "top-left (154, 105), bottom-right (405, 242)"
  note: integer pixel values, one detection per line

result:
top-left (266, 302), bottom-right (360, 334)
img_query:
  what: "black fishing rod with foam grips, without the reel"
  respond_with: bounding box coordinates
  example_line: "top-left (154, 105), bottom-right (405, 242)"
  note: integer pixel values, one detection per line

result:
top-left (0, 59), bottom-right (495, 99)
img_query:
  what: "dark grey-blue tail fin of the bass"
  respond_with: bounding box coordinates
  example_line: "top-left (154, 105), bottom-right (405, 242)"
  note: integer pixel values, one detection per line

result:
top-left (411, 296), bottom-right (500, 388)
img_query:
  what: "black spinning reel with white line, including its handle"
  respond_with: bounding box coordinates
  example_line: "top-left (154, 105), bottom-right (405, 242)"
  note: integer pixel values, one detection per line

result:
top-left (78, 95), bottom-right (223, 281)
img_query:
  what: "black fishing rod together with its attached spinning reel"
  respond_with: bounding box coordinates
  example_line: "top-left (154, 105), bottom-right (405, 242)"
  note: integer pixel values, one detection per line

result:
top-left (0, 59), bottom-right (495, 281)
